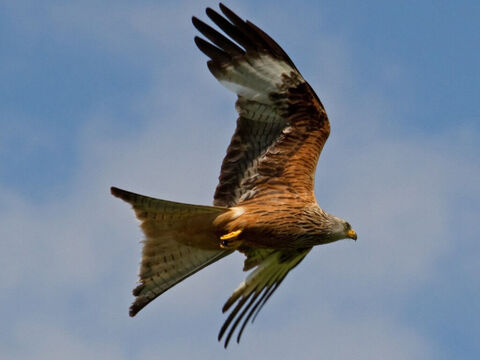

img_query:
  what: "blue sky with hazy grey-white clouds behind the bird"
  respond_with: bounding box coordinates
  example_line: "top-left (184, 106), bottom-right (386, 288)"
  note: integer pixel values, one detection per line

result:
top-left (0, 0), bottom-right (480, 360)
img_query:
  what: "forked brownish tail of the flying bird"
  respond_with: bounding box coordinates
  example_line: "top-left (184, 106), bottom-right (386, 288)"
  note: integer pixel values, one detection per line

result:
top-left (111, 187), bottom-right (231, 316)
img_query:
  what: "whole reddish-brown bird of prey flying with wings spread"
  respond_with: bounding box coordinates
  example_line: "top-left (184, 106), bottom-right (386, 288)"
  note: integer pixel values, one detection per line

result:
top-left (111, 4), bottom-right (357, 347)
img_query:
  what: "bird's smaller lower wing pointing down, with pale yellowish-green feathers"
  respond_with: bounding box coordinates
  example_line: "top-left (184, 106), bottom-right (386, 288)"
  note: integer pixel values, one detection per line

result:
top-left (218, 248), bottom-right (311, 347)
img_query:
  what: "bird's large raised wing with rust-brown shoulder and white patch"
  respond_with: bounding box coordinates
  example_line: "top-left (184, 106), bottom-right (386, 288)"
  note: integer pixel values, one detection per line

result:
top-left (192, 4), bottom-right (330, 206)
